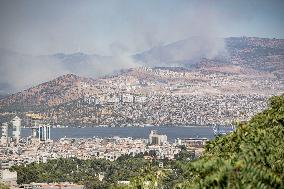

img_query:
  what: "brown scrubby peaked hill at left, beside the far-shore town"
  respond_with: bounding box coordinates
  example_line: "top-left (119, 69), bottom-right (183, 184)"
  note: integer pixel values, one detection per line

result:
top-left (0, 74), bottom-right (96, 109)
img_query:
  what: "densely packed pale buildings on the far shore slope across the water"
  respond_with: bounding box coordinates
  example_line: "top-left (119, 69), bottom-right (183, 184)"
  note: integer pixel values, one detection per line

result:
top-left (44, 94), bottom-right (267, 127)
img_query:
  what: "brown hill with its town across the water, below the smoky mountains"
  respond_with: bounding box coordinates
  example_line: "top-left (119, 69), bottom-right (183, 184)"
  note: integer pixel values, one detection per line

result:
top-left (0, 66), bottom-right (284, 126)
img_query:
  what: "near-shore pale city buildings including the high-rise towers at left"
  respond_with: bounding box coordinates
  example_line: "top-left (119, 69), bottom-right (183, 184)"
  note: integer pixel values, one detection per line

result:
top-left (0, 114), bottom-right (208, 187)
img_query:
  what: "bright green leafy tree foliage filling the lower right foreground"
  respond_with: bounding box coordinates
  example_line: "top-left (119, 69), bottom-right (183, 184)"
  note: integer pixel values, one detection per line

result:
top-left (176, 95), bottom-right (284, 188)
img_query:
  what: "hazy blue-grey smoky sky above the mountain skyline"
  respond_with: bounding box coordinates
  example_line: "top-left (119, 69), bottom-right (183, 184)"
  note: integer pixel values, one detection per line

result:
top-left (0, 0), bottom-right (284, 55)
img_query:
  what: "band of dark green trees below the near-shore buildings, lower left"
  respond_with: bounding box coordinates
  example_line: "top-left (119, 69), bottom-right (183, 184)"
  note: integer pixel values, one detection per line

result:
top-left (11, 156), bottom-right (153, 188)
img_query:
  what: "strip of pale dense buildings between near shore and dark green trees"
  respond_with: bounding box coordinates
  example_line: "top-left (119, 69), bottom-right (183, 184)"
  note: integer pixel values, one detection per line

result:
top-left (0, 119), bottom-right (205, 170)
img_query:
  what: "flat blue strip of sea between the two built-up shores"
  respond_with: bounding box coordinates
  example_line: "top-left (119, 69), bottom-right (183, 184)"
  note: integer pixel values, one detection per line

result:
top-left (21, 126), bottom-right (233, 141)
